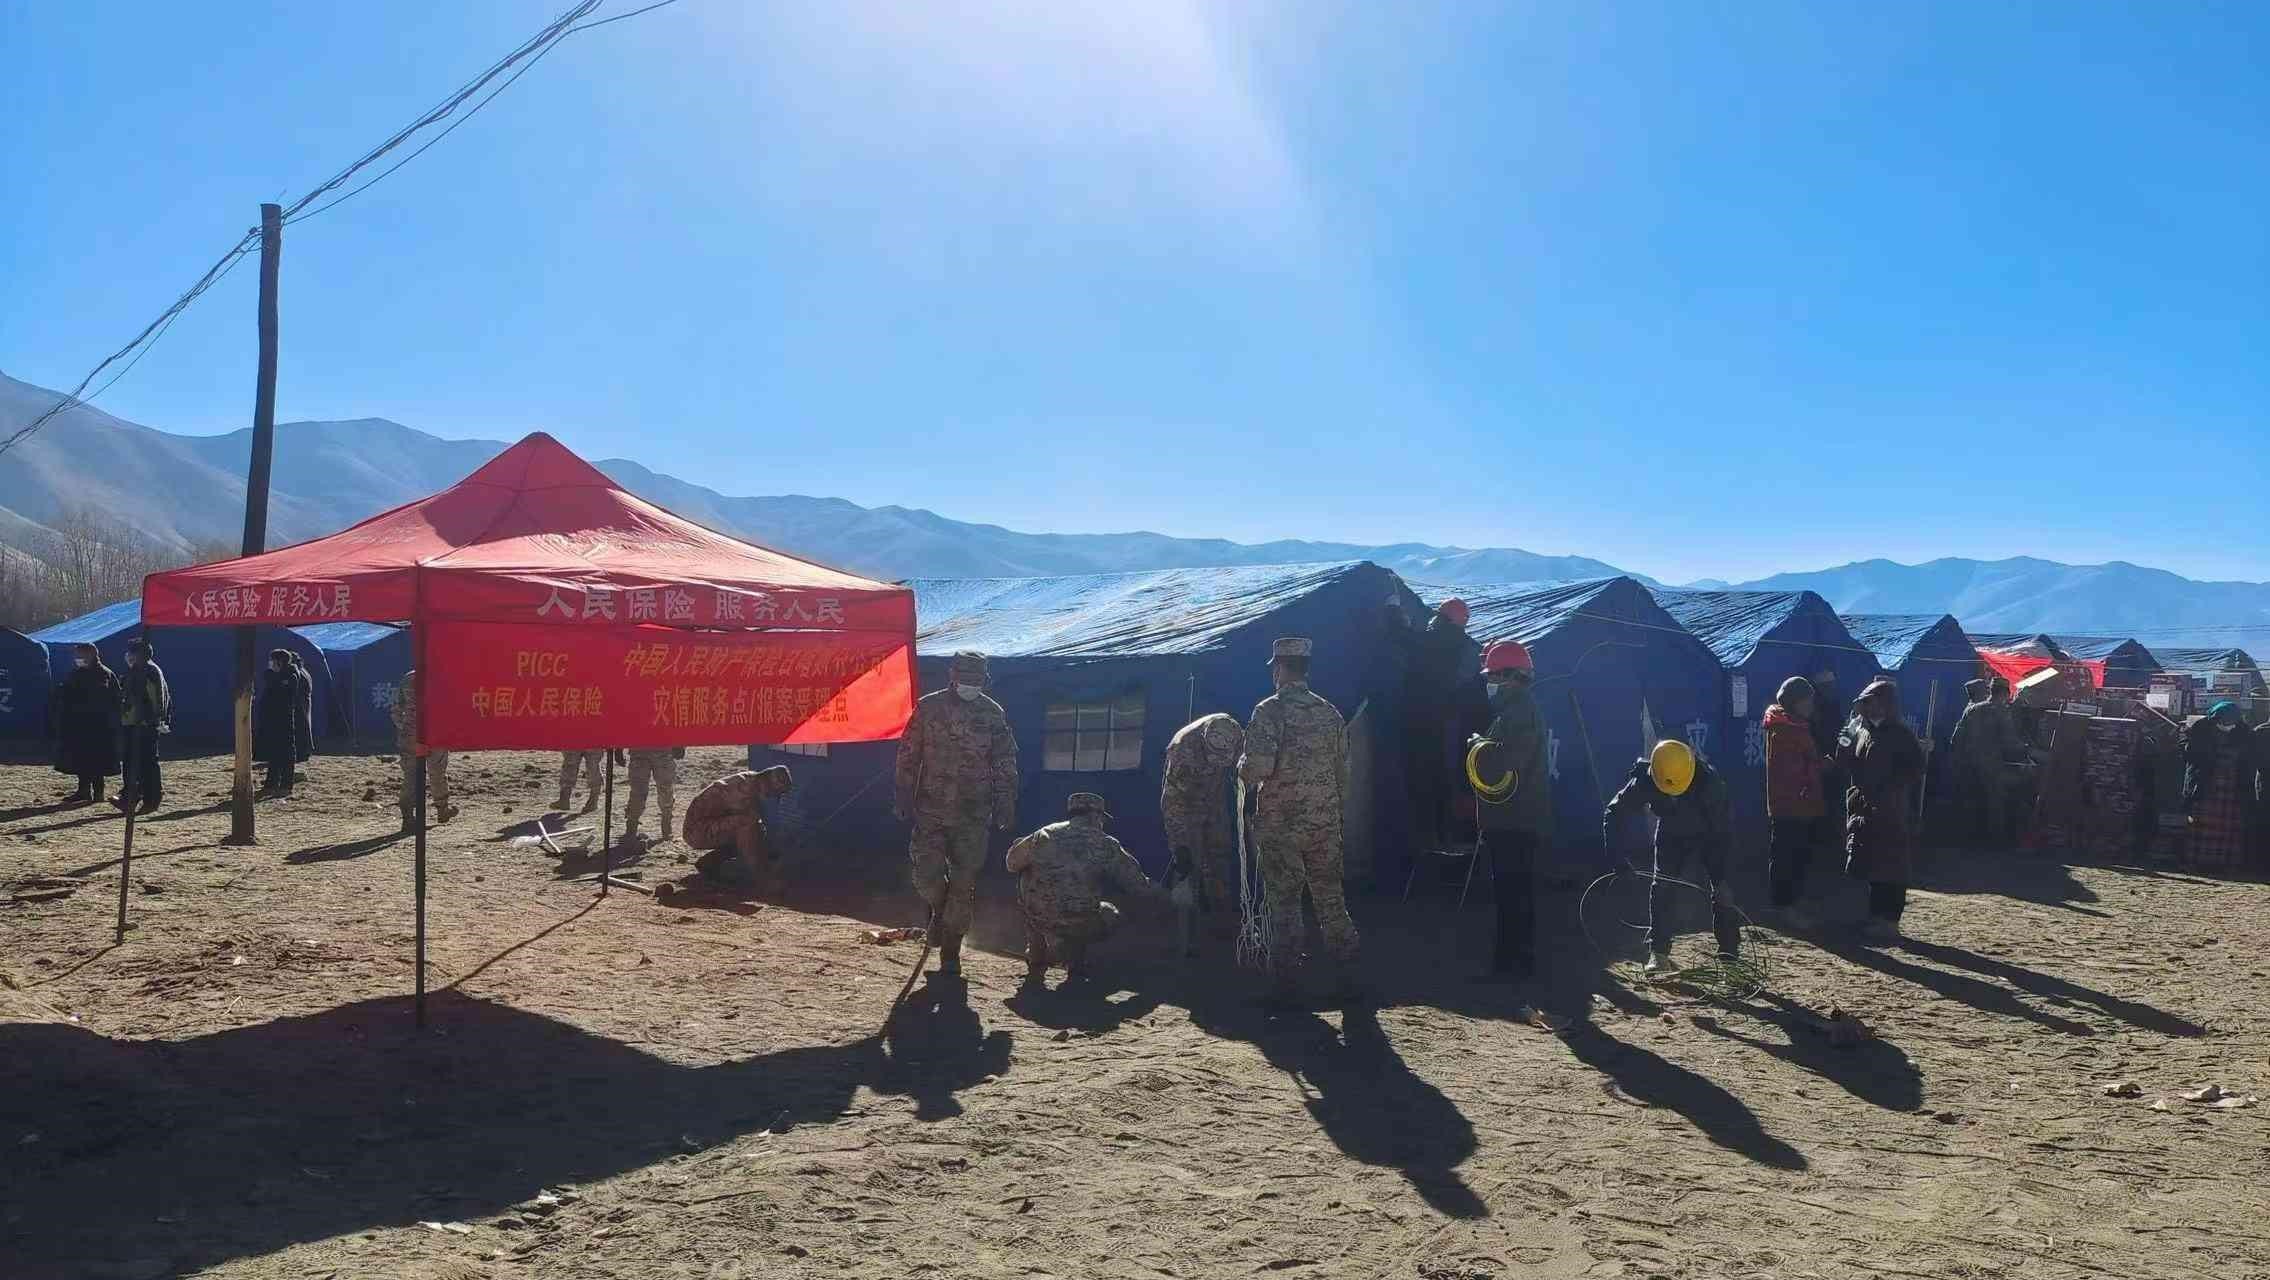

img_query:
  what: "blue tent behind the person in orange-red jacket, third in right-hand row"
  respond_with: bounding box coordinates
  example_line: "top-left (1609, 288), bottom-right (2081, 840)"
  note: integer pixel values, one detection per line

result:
top-left (1655, 590), bottom-right (1905, 840)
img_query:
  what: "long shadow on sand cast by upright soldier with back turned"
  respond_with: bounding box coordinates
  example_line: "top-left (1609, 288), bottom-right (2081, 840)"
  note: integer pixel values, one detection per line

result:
top-left (1189, 1001), bottom-right (1489, 1219)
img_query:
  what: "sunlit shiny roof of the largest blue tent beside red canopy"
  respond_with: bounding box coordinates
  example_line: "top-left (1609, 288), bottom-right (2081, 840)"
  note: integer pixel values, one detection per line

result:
top-left (908, 563), bottom-right (1385, 658)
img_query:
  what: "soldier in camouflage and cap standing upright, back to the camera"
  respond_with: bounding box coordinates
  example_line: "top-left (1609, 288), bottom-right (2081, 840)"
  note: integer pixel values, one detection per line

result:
top-left (1237, 638), bottom-right (1355, 1001)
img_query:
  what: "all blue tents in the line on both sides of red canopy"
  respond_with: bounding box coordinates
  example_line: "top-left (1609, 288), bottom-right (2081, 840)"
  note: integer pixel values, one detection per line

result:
top-left (0, 563), bottom-right (2263, 876)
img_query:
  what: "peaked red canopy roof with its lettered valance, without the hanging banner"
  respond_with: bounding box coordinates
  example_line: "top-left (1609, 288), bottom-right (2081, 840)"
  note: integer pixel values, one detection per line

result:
top-left (143, 431), bottom-right (915, 633)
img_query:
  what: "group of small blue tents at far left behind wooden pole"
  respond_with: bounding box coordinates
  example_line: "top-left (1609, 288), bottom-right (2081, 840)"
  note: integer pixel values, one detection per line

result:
top-left (0, 599), bottom-right (411, 751)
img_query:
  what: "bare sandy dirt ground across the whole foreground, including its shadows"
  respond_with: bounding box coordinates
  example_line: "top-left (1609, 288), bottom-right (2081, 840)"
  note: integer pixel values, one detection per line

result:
top-left (0, 751), bottom-right (2270, 1280)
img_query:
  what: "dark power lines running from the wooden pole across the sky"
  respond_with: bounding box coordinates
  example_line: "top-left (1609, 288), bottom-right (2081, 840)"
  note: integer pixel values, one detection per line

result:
top-left (0, 0), bottom-right (676, 454)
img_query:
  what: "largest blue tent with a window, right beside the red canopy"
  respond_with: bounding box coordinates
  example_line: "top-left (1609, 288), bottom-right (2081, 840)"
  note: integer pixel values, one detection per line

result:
top-left (771, 563), bottom-right (1423, 878)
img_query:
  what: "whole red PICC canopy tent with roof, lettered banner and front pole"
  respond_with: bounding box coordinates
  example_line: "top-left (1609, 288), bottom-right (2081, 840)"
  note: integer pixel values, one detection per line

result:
top-left (120, 431), bottom-right (915, 1017)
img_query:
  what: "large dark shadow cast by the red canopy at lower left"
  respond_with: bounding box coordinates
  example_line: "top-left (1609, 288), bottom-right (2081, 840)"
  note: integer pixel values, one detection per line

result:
top-left (0, 992), bottom-right (1010, 1280)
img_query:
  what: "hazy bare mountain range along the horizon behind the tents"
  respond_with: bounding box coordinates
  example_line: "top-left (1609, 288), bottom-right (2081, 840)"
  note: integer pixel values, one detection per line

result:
top-left (0, 374), bottom-right (2270, 649)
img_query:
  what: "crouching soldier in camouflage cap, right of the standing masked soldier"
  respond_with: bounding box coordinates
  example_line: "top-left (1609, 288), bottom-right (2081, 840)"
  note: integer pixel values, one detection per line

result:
top-left (1008, 792), bottom-right (1165, 985)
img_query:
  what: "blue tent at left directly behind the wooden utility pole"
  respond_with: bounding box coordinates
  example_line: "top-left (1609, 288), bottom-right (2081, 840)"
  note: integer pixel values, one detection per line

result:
top-left (32, 599), bottom-right (331, 756)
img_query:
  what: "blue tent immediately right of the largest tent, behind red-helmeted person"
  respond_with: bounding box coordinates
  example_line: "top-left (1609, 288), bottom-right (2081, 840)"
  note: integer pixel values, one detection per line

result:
top-left (1419, 579), bottom-right (1721, 869)
